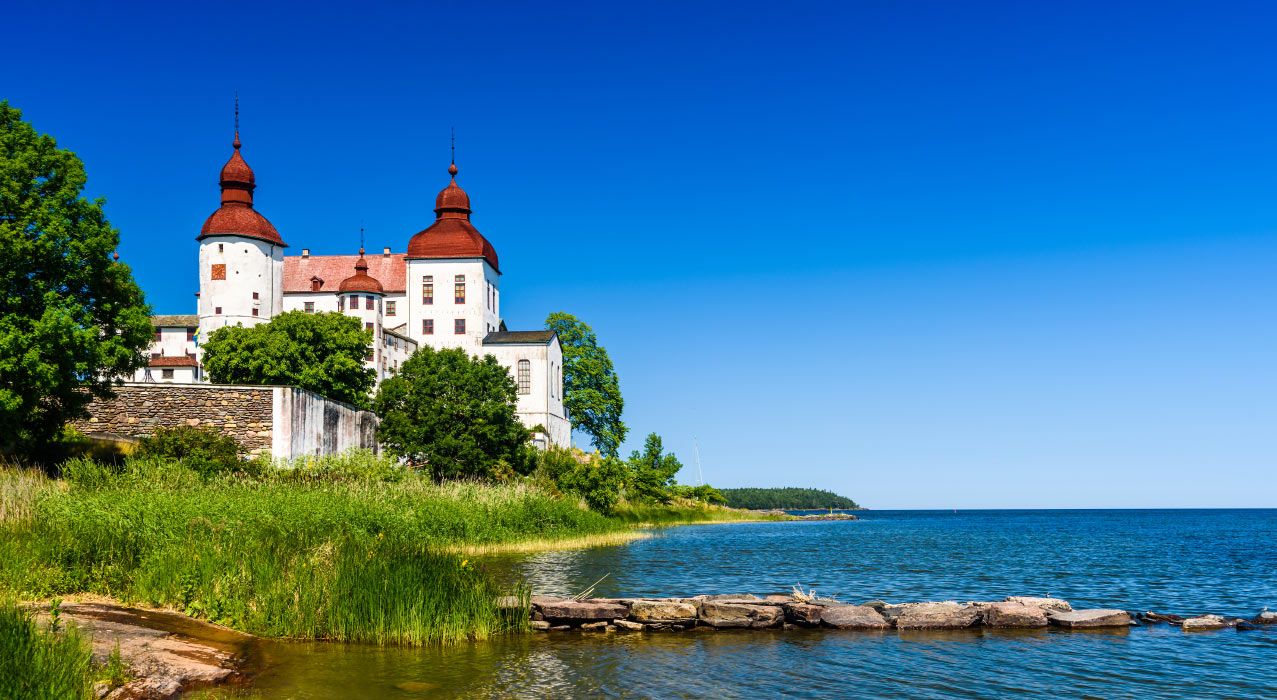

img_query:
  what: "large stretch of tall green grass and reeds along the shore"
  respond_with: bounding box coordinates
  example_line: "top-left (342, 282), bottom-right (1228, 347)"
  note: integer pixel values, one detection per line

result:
top-left (0, 452), bottom-right (776, 644)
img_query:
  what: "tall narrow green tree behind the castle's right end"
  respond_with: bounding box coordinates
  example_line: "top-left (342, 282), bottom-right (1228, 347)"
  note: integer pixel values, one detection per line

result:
top-left (545, 312), bottom-right (628, 457)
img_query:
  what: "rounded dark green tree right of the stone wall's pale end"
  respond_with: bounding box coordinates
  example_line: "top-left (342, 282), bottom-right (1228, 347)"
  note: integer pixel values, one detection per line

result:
top-left (373, 346), bottom-right (535, 480)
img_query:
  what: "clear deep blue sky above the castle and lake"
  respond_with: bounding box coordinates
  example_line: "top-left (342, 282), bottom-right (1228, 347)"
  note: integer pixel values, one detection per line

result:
top-left (0, 1), bottom-right (1277, 508)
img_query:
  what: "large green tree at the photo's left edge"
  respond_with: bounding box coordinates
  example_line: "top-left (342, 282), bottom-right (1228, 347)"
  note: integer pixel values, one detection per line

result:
top-left (0, 101), bottom-right (152, 456)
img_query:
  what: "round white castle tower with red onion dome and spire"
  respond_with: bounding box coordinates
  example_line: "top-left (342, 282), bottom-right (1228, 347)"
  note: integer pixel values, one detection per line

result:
top-left (195, 112), bottom-right (287, 347)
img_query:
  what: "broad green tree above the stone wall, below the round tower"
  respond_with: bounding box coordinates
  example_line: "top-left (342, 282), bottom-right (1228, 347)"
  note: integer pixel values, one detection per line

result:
top-left (196, 312), bottom-right (375, 409)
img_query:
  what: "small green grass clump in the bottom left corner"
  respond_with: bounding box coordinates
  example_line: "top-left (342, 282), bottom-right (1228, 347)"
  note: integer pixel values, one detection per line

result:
top-left (0, 600), bottom-right (93, 700)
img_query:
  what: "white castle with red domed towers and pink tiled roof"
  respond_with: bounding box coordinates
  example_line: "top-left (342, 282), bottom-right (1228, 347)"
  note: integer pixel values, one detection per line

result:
top-left (134, 129), bottom-right (571, 446)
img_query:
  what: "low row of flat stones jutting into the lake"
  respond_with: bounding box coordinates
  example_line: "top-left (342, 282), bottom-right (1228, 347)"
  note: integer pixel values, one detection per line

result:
top-left (515, 594), bottom-right (1277, 631)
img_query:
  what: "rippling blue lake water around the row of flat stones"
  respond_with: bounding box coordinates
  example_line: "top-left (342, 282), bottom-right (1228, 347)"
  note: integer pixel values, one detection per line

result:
top-left (234, 510), bottom-right (1277, 700)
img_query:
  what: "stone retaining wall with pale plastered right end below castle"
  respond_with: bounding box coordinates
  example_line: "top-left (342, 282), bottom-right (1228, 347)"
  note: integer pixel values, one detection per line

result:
top-left (73, 382), bottom-right (378, 457)
